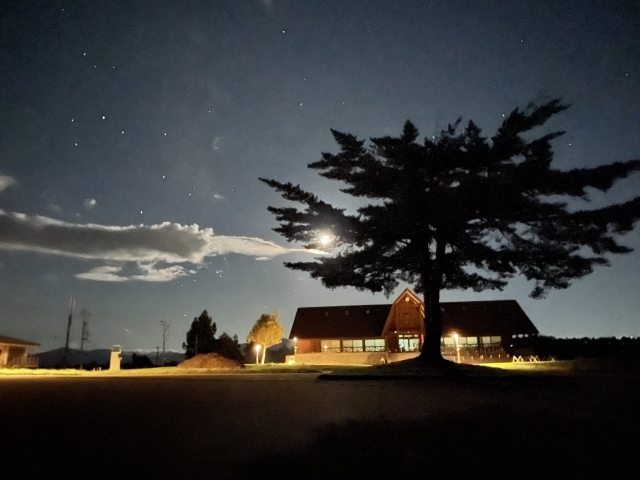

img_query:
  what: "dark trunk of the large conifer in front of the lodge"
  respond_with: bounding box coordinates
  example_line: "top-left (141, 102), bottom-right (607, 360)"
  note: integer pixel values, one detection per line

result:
top-left (419, 241), bottom-right (446, 364)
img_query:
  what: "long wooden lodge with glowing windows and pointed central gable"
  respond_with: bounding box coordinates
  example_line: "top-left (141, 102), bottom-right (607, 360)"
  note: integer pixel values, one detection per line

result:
top-left (289, 289), bottom-right (538, 364)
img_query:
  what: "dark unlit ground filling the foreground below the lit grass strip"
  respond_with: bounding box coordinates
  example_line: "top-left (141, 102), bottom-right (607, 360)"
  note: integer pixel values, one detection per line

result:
top-left (0, 374), bottom-right (640, 479)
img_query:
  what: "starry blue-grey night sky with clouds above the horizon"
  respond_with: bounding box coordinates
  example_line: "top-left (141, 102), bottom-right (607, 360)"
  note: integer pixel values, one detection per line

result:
top-left (0, 0), bottom-right (640, 350)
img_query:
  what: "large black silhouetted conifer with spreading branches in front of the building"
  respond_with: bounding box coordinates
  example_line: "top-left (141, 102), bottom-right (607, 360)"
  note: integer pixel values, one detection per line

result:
top-left (261, 99), bottom-right (640, 363)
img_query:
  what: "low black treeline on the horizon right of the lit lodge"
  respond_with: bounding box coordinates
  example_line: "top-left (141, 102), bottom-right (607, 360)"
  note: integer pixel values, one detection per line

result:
top-left (535, 336), bottom-right (640, 360)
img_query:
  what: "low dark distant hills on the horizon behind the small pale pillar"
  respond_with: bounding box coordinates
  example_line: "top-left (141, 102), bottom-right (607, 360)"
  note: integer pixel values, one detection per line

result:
top-left (36, 348), bottom-right (184, 368)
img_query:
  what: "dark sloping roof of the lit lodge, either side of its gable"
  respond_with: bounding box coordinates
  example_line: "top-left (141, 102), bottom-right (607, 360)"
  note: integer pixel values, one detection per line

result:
top-left (289, 300), bottom-right (538, 339)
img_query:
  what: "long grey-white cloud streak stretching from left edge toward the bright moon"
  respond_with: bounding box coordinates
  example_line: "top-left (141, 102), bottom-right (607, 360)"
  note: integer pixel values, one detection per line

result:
top-left (0, 210), bottom-right (323, 282)
